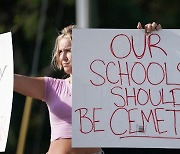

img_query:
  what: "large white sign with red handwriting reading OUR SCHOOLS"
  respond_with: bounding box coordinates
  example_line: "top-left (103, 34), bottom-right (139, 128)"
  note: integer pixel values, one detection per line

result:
top-left (72, 29), bottom-right (180, 148)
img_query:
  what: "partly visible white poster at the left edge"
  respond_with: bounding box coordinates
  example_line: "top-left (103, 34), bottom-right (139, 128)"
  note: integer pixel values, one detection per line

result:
top-left (0, 32), bottom-right (13, 152)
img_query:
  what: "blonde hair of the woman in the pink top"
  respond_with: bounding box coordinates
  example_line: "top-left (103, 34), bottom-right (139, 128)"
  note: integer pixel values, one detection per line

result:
top-left (51, 25), bottom-right (75, 70)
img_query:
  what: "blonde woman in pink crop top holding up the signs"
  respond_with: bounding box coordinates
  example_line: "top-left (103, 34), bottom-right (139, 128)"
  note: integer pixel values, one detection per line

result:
top-left (14, 22), bottom-right (161, 154)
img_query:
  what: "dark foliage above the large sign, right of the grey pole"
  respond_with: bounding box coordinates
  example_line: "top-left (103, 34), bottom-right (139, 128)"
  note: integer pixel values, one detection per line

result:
top-left (98, 0), bottom-right (180, 28)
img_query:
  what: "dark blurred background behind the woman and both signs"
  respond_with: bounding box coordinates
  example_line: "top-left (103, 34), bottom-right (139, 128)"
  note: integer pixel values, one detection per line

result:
top-left (0, 0), bottom-right (180, 154)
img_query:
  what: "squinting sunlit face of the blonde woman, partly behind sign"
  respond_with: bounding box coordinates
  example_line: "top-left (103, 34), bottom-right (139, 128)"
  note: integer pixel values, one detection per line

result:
top-left (56, 36), bottom-right (72, 74)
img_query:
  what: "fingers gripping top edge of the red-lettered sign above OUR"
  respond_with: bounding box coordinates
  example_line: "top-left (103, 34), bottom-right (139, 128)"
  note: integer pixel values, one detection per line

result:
top-left (137, 22), bottom-right (162, 34)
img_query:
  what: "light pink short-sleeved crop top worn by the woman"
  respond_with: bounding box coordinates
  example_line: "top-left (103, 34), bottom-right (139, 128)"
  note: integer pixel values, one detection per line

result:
top-left (44, 77), bottom-right (72, 141)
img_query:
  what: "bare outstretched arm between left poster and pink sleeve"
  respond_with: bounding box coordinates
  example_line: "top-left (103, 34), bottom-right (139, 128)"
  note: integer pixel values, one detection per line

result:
top-left (14, 74), bottom-right (45, 100)
